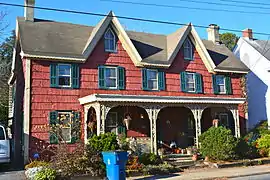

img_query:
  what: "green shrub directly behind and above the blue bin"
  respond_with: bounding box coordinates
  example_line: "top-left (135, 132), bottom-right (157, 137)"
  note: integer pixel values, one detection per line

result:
top-left (88, 133), bottom-right (119, 152)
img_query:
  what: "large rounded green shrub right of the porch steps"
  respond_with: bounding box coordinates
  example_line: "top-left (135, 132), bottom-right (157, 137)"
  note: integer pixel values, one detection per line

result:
top-left (199, 126), bottom-right (237, 160)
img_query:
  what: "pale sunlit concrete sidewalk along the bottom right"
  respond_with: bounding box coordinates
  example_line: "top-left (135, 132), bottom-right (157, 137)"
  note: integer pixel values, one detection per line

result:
top-left (128, 165), bottom-right (270, 180)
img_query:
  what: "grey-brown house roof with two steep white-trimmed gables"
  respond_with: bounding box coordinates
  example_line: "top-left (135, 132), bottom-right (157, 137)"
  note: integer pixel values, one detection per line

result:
top-left (17, 12), bottom-right (248, 72)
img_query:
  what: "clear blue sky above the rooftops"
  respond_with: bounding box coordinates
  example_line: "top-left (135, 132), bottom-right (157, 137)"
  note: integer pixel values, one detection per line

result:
top-left (0, 0), bottom-right (270, 39)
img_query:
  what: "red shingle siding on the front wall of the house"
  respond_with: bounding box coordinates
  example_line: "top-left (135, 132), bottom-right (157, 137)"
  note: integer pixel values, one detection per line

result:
top-left (31, 37), bottom-right (245, 156)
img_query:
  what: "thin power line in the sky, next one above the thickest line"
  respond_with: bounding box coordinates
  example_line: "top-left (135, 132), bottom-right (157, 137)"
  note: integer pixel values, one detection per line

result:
top-left (100, 0), bottom-right (270, 15)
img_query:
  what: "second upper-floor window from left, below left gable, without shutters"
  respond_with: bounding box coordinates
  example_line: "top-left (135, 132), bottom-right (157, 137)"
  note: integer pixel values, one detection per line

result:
top-left (105, 67), bottom-right (117, 89)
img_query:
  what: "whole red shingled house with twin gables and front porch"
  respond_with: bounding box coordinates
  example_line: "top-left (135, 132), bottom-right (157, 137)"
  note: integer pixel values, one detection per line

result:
top-left (10, 1), bottom-right (248, 161)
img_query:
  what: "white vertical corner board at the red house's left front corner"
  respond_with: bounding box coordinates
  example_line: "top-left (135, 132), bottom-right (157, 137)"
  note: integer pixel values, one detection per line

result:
top-left (23, 59), bottom-right (31, 163)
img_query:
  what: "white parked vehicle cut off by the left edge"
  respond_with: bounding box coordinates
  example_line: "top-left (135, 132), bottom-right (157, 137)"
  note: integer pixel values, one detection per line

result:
top-left (0, 125), bottom-right (10, 163)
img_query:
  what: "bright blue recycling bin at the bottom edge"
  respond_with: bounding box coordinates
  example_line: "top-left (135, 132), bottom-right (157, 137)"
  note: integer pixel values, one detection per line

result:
top-left (102, 151), bottom-right (128, 180)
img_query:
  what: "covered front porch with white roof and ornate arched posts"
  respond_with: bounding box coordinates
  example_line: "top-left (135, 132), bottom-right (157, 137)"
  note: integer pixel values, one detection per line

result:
top-left (79, 94), bottom-right (244, 153)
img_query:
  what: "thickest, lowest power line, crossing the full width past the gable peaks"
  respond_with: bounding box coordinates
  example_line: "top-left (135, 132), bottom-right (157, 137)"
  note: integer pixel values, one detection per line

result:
top-left (0, 2), bottom-right (270, 36)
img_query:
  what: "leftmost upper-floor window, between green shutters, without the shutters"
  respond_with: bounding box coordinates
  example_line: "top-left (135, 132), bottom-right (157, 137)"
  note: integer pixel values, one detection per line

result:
top-left (58, 64), bottom-right (71, 87)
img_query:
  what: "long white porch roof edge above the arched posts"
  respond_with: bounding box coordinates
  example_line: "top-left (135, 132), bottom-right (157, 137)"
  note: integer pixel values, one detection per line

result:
top-left (79, 94), bottom-right (245, 104)
